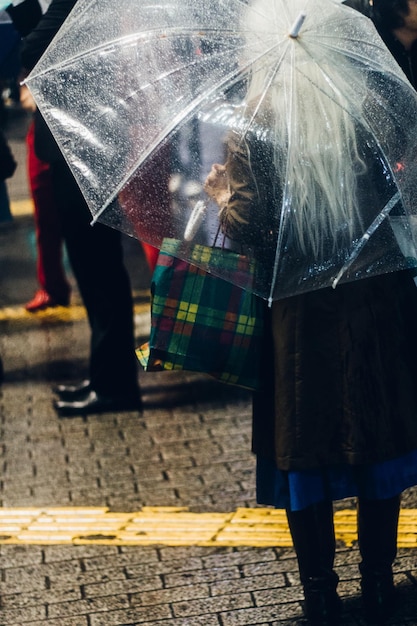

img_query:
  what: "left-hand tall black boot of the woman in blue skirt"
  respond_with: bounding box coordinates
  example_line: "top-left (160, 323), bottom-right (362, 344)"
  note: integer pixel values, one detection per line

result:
top-left (287, 502), bottom-right (341, 626)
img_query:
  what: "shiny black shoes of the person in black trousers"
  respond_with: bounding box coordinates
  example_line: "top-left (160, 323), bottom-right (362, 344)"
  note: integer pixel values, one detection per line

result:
top-left (54, 391), bottom-right (142, 417)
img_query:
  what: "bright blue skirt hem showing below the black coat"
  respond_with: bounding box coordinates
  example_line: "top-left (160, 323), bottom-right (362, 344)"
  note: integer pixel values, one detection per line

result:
top-left (256, 451), bottom-right (417, 511)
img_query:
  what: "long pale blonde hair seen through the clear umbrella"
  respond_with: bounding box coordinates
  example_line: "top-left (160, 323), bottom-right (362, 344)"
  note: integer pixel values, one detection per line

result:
top-left (243, 0), bottom-right (366, 258)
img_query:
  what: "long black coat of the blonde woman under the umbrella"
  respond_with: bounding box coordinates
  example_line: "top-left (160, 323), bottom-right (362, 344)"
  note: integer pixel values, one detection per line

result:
top-left (220, 130), bottom-right (417, 470)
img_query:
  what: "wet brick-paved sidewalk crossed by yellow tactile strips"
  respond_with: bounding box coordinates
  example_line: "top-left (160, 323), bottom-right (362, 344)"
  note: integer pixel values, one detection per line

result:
top-left (0, 105), bottom-right (417, 626)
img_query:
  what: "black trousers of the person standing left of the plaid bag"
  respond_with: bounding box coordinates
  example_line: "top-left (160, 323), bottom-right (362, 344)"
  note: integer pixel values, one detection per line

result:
top-left (51, 161), bottom-right (138, 395)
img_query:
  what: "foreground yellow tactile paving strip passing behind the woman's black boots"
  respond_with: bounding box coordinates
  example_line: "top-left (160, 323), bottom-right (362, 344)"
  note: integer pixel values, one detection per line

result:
top-left (0, 507), bottom-right (417, 548)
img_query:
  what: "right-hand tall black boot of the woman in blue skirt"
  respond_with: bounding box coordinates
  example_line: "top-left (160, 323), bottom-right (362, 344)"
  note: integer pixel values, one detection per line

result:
top-left (358, 496), bottom-right (401, 624)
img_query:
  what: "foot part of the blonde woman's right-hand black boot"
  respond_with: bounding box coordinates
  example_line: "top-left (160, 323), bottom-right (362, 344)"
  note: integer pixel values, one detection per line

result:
top-left (361, 574), bottom-right (398, 624)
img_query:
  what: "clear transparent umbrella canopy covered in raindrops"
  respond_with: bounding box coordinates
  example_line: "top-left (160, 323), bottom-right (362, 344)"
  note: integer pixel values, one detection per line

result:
top-left (27, 0), bottom-right (417, 300)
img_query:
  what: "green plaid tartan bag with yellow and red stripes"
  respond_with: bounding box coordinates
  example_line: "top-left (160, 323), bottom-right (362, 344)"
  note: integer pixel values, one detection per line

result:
top-left (136, 239), bottom-right (264, 389)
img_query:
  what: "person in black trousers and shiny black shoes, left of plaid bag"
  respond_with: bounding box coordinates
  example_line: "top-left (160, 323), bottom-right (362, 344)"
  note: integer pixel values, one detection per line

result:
top-left (21, 0), bottom-right (141, 416)
